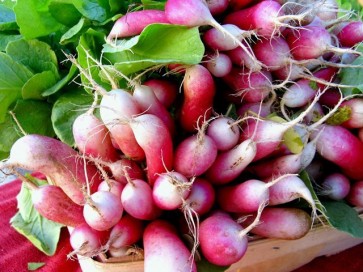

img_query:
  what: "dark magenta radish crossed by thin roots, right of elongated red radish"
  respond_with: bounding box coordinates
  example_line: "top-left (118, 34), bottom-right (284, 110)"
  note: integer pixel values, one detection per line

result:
top-left (222, 67), bottom-right (273, 102)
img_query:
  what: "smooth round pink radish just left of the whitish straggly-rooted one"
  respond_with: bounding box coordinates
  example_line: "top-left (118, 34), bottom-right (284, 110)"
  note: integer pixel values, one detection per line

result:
top-left (121, 179), bottom-right (161, 220)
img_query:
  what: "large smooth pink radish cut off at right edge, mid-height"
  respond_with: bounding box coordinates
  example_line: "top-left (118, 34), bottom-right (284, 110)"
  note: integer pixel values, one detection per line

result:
top-left (311, 124), bottom-right (363, 180)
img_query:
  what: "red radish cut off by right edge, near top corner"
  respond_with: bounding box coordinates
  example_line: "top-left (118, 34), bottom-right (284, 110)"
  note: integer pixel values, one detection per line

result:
top-left (333, 21), bottom-right (363, 47)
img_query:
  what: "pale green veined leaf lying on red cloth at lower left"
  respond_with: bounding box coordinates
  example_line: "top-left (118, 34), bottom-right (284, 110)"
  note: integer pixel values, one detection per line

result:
top-left (10, 181), bottom-right (63, 256)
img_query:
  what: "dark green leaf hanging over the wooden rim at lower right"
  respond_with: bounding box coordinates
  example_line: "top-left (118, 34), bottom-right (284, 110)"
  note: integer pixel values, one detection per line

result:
top-left (322, 201), bottom-right (363, 238)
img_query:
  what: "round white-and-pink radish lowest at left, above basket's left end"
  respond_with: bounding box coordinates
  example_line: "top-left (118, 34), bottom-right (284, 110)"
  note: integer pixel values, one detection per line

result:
top-left (69, 223), bottom-right (109, 257)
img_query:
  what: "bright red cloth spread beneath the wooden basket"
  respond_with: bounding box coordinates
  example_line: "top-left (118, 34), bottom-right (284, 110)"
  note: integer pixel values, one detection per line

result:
top-left (0, 180), bottom-right (363, 272)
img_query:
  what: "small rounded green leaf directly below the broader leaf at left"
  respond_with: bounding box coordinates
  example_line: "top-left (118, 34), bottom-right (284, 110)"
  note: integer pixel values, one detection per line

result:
top-left (22, 71), bottom-right (57, 100)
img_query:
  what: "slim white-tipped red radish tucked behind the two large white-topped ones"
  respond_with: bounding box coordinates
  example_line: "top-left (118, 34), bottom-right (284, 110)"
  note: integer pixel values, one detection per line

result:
top-left (133, 85), bottom-right (175, 135)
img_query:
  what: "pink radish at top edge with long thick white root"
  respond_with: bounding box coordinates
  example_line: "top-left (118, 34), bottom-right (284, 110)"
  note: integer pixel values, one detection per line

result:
top-left (165, 0), bottom-right (260, 70)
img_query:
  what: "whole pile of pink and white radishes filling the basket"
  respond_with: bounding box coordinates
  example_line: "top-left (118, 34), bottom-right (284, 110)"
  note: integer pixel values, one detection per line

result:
top-left (6, 0), bottom-right (363, 271)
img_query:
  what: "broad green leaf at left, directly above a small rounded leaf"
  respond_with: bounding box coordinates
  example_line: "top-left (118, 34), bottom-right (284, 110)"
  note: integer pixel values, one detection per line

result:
top-left (6, 39), bottom-right (58, 74)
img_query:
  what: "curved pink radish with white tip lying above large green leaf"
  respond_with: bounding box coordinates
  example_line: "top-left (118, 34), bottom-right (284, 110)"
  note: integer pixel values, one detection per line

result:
top-left (107, 9), bottom-right (169, 40)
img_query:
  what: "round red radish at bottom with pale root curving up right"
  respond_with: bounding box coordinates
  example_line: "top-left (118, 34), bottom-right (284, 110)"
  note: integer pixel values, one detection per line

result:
top-left (199, 206), bottom-right (264, 266)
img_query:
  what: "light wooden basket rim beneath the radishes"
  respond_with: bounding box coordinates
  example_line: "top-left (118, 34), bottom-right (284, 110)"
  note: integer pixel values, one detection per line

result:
top-left (79, 214), bottom-right (363, 272)
